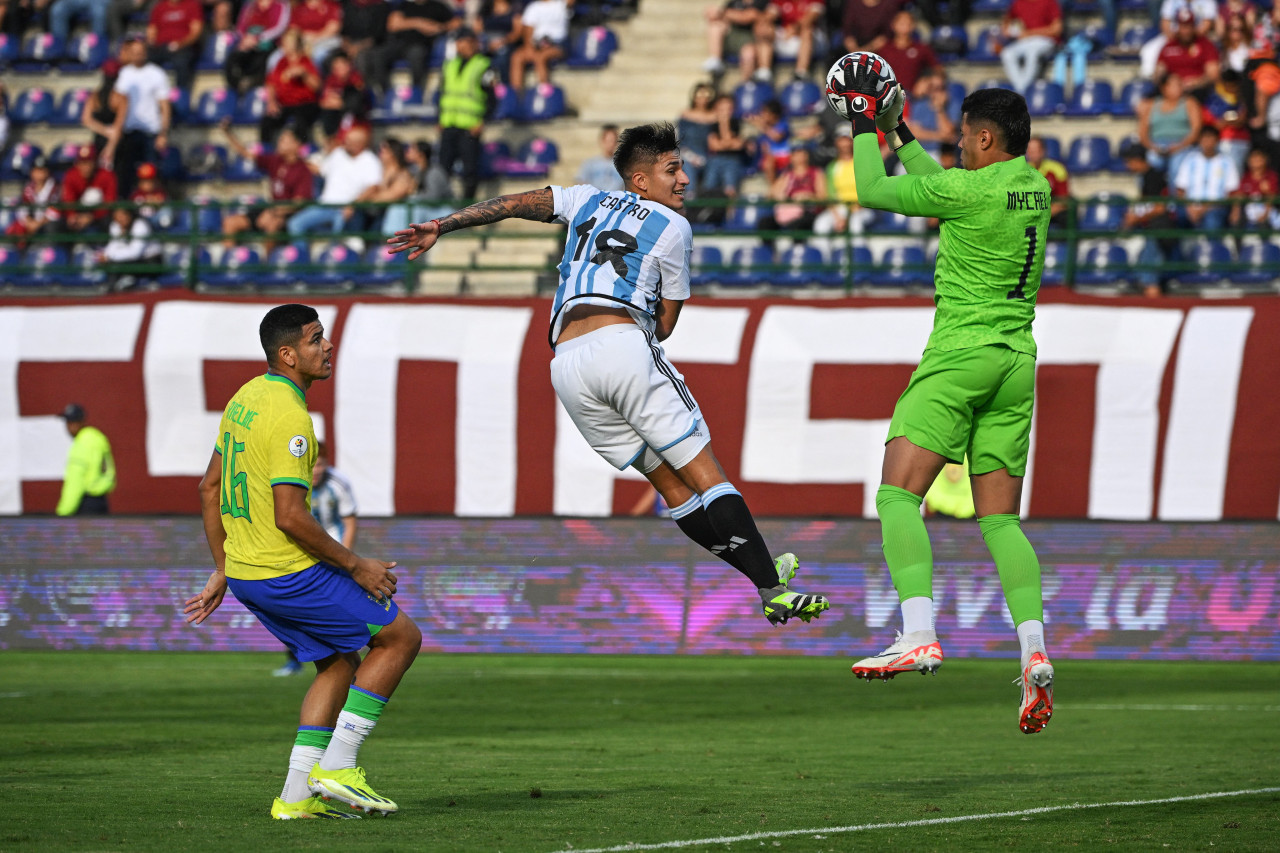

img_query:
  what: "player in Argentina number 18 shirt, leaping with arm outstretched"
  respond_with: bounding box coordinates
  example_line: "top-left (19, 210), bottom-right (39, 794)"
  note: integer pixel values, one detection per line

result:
top-left (388, 123), bottom-right (829, 624)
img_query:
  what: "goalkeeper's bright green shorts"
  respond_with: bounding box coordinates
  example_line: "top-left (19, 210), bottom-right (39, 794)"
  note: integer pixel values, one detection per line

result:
top-left (884, 345), bottom-right (1036, 476)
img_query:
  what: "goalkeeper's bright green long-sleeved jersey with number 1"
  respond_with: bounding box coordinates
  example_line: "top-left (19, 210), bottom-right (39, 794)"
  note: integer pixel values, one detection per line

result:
top-left (854, 133), bottom-right (1050, 356)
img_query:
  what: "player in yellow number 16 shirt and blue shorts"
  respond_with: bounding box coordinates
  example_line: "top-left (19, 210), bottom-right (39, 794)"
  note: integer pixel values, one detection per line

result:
top-left (186, 305), bottom-right (422, 820)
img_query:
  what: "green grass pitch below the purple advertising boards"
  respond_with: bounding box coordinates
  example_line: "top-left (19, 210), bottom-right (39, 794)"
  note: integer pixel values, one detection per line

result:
top-left (0, 652), bottom-right (1280, 852)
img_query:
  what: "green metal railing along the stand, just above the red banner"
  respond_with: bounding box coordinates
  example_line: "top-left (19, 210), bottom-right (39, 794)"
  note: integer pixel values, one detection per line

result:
top-left (0, 199), bottom-right (1280, 293)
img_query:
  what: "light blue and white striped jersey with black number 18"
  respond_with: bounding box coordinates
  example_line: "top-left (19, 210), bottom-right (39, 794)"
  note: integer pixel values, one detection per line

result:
top-left (550, 184), bottom-right (694, 346)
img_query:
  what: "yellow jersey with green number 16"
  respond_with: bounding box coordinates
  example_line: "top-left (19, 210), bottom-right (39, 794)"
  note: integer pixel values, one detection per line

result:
top-left (214, 373), bottom-right (317, 580)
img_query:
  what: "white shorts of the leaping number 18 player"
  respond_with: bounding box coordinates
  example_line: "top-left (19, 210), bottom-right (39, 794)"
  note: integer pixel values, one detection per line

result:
top-left (552, 323), bottom-right (710, 474)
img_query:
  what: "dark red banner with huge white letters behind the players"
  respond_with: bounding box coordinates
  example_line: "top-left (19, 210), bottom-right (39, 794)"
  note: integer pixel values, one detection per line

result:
top-left (0, 293), bottom-right (1280, 521)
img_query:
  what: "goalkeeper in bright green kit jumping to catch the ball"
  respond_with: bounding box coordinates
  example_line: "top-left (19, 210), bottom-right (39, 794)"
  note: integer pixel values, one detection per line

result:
top-left (845, 54), bottom-right (1053, 734)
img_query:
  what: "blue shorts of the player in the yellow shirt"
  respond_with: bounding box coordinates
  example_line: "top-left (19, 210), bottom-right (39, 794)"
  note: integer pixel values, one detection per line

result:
top-left (227, 562), bottom-right (399, 661)
